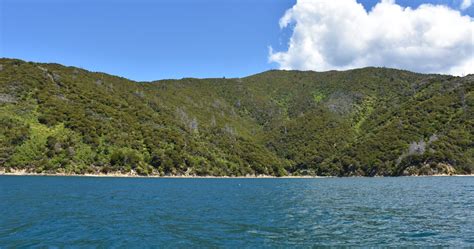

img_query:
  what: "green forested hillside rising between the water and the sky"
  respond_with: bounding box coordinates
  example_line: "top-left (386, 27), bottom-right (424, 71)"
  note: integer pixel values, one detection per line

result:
top-left (0, 59), bottom-right (474, 176)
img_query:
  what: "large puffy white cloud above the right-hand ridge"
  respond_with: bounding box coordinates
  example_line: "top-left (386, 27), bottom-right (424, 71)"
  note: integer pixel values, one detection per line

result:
top-left (269, 0), bottom-right (474, 75)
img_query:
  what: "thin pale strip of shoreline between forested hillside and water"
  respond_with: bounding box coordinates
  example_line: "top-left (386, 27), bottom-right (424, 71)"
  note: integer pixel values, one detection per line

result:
top-left (0, 170), bottom-right (474, 179)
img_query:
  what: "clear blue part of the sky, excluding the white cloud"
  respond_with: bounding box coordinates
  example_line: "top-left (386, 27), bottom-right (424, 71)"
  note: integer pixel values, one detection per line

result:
top-left (0, 0), bottom-right (473, 80)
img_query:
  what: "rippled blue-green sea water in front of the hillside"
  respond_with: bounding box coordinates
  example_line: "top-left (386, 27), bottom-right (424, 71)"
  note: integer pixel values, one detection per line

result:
top-left (0, 176), bottom-right (474, 248)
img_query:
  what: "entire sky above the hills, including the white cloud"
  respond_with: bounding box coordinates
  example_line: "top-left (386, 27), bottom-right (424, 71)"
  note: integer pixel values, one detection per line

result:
top-left (0, 0), bottom-right (474, 81)
